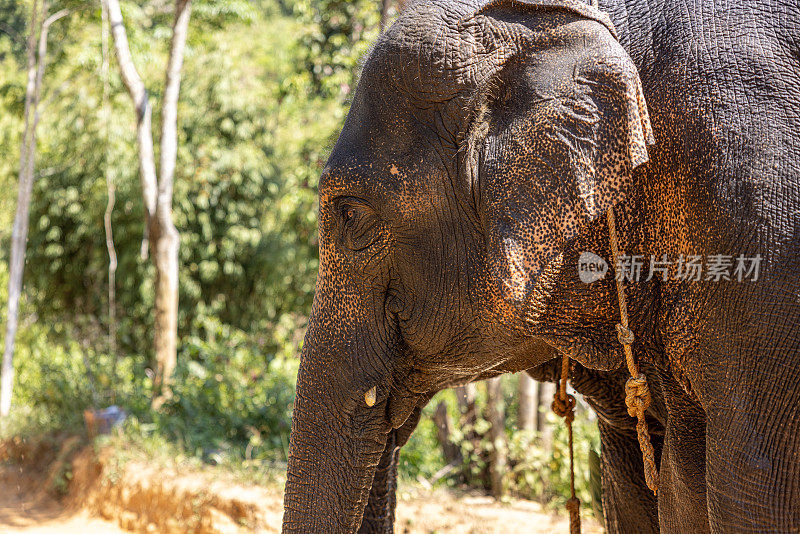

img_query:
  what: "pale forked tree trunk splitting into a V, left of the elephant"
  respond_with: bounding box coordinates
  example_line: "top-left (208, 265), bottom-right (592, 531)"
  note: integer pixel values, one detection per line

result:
top-left (104, 0), bottom-right (192, 408)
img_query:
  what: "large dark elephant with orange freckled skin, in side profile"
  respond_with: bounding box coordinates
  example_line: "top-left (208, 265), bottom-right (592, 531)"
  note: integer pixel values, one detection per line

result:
top-left (283, 0), bottom-right (800, 533)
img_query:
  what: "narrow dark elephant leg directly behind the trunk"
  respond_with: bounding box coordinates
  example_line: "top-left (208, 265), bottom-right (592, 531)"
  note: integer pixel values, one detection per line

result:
top-left (358, 406), bottom-right (428, 534)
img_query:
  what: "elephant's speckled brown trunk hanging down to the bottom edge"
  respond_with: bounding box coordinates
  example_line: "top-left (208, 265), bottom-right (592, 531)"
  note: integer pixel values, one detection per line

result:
top-left (283, 342), bottom-right (391, 534)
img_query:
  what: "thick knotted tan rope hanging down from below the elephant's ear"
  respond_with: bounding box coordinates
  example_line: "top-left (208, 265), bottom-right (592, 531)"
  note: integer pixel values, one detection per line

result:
top-left (608, 208), bottom-right (658, 494)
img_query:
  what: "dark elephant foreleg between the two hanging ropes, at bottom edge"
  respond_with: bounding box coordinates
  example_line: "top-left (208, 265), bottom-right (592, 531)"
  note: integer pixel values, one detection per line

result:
top-left (599, 419), bottom-right (661, 534)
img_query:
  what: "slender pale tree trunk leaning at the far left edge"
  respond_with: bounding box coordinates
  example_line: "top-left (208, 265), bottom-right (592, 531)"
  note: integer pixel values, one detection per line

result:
top-left (0, 0), bottom-right (69, 417)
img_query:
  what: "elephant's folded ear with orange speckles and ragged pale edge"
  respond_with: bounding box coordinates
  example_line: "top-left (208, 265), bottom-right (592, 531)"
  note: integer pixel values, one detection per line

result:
top-left (461, 0), bottom-right (653, 308)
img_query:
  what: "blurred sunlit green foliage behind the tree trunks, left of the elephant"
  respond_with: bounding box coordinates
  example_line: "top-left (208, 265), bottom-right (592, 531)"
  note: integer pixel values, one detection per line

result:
top-left (0, 0), bottom-right (354, 468)
